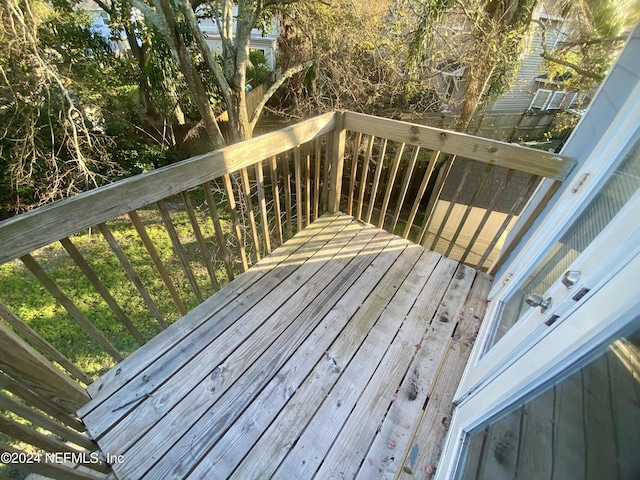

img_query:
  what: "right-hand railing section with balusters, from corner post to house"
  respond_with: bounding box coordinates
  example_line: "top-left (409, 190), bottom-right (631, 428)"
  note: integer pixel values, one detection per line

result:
top-left (340, 112), bottom-right (574, 270)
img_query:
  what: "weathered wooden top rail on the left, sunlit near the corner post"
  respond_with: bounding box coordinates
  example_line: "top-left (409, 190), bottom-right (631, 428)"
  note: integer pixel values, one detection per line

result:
top-left (0, 112), bottom-right (336, 265)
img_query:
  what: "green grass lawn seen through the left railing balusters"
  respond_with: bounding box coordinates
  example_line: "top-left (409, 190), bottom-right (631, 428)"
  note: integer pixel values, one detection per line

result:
top-left (0, 190), bottom-right (262, 478)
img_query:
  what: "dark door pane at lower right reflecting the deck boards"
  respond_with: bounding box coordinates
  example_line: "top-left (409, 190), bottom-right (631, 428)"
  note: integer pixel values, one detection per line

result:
top-left (456, 317), bottom-right (640, 480)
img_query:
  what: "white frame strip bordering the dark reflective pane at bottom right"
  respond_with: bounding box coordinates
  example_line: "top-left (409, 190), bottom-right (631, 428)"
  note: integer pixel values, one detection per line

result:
top-left (435, 249), bottom-right (640, 480)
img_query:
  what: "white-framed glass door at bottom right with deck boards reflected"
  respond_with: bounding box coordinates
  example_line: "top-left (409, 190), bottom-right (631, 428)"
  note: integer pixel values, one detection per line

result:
top-left (436, 248), bottom-right (640, 480)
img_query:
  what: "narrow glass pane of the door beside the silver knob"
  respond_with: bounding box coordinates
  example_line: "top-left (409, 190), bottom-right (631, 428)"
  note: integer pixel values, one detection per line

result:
top-left (484, 136), bottom-right (640, 353)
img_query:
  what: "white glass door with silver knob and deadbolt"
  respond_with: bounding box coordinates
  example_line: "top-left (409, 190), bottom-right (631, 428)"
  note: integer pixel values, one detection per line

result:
top-left (456, 118), bottom-right (640, 400)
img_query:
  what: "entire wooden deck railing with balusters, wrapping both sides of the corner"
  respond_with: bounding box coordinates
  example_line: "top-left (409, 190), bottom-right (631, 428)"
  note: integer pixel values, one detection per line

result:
top-left (0, 112), bottom-right (571, 478)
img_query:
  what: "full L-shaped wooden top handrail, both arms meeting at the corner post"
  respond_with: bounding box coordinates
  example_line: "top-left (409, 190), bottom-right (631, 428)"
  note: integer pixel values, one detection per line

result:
top-left (0, 112), bottom-right (575, 265)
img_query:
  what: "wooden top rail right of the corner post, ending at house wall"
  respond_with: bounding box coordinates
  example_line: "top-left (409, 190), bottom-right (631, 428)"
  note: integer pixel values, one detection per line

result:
top-left (344, 112), bottom-right (576, 180)
